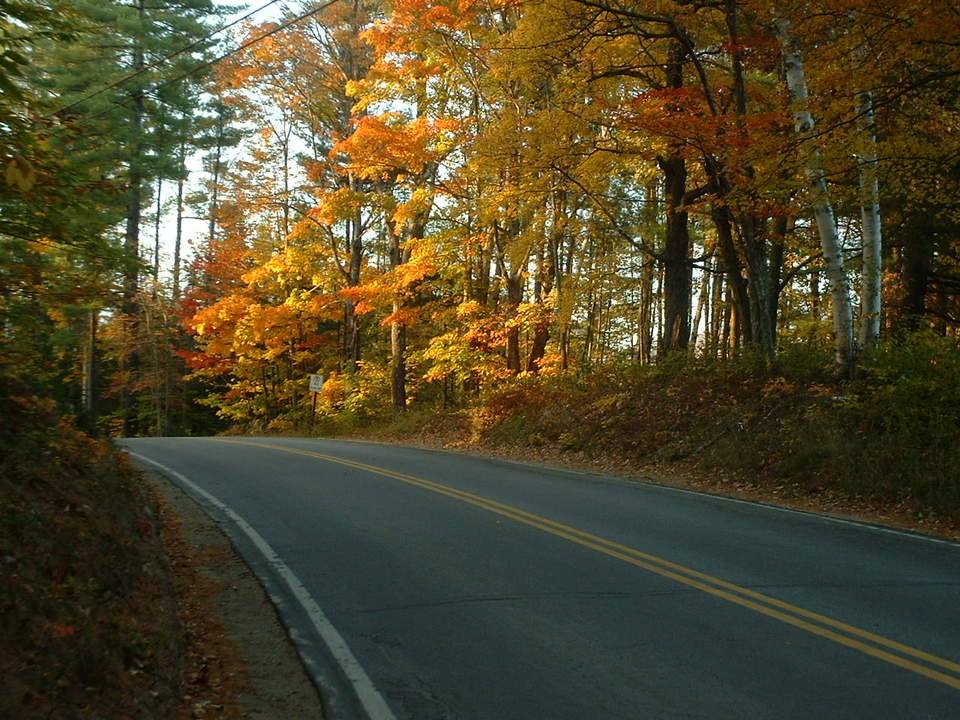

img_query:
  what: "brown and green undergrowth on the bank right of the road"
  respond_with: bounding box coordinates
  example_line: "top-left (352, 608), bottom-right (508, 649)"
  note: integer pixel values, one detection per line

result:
top-left (354, 333), bottom-right (960, 524)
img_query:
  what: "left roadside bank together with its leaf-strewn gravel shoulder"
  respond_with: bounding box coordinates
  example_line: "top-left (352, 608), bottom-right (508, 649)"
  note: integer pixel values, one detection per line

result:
top-left (0, 380), bottom-right (322, 720)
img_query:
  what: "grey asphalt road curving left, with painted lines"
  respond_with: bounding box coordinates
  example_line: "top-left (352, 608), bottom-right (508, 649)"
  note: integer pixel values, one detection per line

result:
top-left (123, 438), bottom-right (960, 720)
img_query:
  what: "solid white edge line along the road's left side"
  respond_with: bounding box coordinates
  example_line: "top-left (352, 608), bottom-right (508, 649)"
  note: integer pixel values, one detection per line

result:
top-left (127, 450), bottom-right (396, 720)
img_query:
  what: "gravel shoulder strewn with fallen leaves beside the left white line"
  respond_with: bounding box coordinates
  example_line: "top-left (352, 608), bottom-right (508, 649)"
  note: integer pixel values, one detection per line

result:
top-left (143, 470), bottom-right (323, 720)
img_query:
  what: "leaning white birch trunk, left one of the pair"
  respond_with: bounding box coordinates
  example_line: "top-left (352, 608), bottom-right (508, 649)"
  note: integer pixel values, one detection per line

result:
top-left (777, 20), bottom-right (855, 375)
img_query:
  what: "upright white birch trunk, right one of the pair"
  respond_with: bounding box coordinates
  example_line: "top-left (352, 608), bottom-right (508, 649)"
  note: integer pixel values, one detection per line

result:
top-left (857, 92), bottom-right (883, 347)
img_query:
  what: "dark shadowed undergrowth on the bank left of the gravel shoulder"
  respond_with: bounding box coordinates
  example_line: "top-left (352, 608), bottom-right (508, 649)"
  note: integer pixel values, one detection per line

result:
top-left (0, 375), bottom-right (179, 719)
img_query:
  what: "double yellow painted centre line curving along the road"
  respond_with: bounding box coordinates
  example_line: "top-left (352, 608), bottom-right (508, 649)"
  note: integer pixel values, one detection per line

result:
top-left (220, 439), bottom-right (960, 690)
